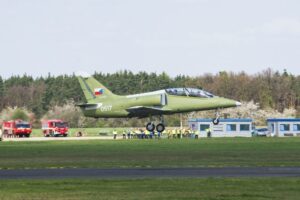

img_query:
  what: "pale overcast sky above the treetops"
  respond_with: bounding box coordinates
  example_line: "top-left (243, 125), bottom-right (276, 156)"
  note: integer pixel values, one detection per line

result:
top-left (0, 0), bottom-right (300, 78)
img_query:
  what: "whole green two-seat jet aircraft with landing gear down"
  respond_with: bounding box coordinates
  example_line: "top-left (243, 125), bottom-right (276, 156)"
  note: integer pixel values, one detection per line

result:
top-left (77, 75), bottom-right (241, 132)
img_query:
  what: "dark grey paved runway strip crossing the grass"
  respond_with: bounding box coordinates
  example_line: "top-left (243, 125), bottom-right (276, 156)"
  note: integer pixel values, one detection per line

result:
top-left (0, 167), bottom-right (300, 179)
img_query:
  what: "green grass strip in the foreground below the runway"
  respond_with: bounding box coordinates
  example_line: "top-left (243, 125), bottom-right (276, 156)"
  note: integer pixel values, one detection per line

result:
top-left (0, 178), bottom-right (300, 200)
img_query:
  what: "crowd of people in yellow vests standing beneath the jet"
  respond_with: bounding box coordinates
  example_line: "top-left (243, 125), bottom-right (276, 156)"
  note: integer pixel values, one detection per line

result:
top-left (113, 128), bottom-right (208, 139)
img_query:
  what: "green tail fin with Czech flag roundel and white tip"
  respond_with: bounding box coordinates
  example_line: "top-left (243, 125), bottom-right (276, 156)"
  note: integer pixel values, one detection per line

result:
top-left (78, 76), bottom-right (115, 102)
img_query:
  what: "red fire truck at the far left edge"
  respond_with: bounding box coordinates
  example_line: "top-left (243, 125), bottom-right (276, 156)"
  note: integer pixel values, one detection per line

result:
top-left (2, 120), bottom-right (32, 137)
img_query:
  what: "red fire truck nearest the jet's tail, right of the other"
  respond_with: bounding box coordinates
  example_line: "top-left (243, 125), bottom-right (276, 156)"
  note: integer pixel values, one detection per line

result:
top-left (42, 119), bottom-right (69, 137)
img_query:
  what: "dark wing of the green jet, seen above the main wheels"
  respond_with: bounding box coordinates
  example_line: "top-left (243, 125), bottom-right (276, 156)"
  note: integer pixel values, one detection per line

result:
top-left (126, 106), bottom-right (168, 118)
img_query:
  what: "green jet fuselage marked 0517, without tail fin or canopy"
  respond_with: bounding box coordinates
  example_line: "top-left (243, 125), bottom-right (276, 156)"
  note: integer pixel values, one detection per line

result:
top-left (82, 91), bottom-right (237, 118)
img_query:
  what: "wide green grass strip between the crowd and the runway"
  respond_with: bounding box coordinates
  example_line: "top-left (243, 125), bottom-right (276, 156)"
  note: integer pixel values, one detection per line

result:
top-left (0, 138), bottom-right (300, 169)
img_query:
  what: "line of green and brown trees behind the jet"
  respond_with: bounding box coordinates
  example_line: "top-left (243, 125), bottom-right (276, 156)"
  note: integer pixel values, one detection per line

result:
top-left (0, 69), bottom-right (300, 125)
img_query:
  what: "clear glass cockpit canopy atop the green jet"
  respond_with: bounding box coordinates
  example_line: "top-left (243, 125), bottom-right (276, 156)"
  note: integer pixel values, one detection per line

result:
top-left (166, 88), bottom-right (214, 98)
